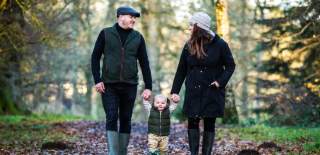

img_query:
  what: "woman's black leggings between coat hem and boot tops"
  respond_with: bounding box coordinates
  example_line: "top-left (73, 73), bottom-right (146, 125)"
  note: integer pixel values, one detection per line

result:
top-left (188, 117), bottom-right (216, 132)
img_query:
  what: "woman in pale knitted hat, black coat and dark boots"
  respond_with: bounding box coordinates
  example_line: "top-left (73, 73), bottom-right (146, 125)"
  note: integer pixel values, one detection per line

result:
top-left (171, 12), bottom-right (235, 155)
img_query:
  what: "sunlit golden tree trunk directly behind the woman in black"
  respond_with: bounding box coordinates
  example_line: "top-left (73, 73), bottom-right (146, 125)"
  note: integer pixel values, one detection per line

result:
top-left (215, 0), bottom-right (239, 123)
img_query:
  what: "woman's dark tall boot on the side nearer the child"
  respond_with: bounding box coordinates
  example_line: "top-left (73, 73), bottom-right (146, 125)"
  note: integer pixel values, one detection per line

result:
top-left (188, 129), bottom-right (200, 155)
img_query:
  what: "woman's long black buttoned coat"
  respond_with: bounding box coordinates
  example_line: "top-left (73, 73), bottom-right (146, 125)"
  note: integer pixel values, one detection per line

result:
top-left (171, 35), bottom-right (235, 117)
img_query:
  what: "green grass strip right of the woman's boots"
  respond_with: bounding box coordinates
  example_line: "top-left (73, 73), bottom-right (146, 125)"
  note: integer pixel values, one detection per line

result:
top-left (217, 125), bottom-right (320, 154)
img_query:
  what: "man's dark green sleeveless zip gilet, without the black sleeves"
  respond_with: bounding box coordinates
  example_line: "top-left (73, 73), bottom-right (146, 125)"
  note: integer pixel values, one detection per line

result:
top-left (102, 26), bottom-right (141, 84)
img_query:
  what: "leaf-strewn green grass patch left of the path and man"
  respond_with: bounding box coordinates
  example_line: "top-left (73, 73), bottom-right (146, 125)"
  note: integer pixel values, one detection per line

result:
top-left (0, 114), bottom-right (93, 149)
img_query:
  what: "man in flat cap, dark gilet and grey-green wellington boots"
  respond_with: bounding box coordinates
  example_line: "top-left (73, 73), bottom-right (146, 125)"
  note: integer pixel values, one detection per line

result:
top-left (91, 6), bottom-right (152, 155)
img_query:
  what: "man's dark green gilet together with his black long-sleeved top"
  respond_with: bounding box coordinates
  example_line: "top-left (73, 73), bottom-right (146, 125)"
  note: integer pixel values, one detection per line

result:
top-left (91, 23), bottom-right (152, 89)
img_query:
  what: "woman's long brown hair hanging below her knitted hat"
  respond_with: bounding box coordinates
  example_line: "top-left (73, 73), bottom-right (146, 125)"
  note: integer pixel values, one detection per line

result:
top-left (188, 24), bottom-right (213, 59)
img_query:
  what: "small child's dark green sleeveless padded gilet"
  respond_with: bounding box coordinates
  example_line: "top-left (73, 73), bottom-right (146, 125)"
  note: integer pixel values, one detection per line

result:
top-left (148, 106), bottom-right (170, 136)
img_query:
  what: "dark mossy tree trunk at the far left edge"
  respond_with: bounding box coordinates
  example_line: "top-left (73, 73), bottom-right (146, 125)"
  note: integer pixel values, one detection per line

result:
top-left (0, 0), bottom-right (25, 114)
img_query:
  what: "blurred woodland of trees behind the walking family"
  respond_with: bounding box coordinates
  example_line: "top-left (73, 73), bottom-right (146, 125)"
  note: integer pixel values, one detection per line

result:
top-left (0, 0), bottom-right (320, 152)
